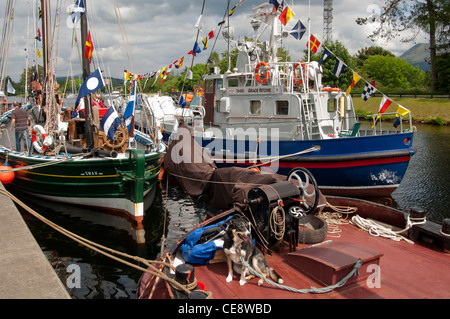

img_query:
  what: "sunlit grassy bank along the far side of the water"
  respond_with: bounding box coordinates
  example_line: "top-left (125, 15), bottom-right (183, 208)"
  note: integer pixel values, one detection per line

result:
top-left (353, 95), bottom-right (450, 125)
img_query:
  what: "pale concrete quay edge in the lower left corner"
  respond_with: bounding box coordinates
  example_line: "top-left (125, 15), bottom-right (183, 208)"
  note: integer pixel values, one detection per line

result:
top-left (0, 183), bottom-right (70, 299)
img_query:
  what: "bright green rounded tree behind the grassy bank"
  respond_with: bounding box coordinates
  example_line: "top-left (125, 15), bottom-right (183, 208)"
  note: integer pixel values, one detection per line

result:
top-left (362, 55), bottom-right (425, 89)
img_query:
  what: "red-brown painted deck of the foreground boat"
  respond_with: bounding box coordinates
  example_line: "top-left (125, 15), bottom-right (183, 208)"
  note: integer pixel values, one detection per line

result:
top-left (191, 224), bottom-right (450, 299)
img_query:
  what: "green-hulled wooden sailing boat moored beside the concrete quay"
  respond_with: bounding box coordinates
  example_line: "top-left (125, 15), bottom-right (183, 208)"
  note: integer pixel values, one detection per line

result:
top-left (0, 0), bottom-right (165, 226)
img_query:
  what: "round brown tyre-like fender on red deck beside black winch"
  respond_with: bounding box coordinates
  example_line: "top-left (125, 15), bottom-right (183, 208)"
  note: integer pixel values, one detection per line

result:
top-left (298, 215), bottom-right (328, 244)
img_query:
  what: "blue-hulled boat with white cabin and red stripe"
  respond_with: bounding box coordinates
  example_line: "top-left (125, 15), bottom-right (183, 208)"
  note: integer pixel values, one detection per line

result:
top-left (143, 3), bottom-right (415, 197)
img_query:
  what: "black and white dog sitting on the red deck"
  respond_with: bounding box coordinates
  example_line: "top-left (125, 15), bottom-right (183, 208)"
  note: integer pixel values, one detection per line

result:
top-left (223, 216), bottom-right (283, 286)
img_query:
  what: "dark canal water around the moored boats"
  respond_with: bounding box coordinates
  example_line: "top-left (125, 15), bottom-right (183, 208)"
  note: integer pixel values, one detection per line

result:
top-left (7, 125), bottom-right (450, 299)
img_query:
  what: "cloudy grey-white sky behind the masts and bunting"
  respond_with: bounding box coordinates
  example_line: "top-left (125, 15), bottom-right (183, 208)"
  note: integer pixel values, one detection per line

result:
top-left (0, 0), bottom-right (427, 81)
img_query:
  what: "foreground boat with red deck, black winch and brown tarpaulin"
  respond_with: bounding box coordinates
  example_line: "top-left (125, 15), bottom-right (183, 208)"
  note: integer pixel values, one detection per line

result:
top-left (138, 123), bottom-right (450, 299)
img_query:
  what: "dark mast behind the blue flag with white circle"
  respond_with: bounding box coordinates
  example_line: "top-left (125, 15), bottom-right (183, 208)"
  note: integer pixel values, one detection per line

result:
top-left (81, 0), bottom-right (94, 148)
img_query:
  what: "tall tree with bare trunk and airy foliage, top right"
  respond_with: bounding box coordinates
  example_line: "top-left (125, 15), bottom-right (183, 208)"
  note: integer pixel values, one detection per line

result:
top-left (356, 0), bottom-right (450, 89)
